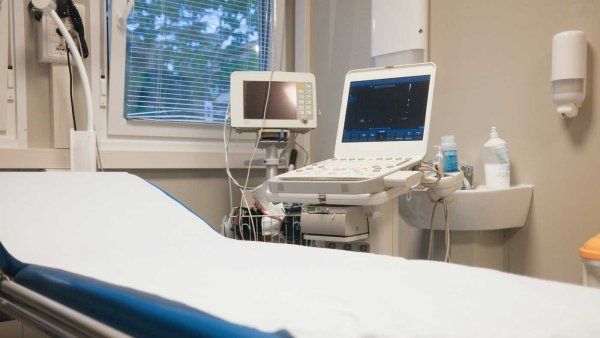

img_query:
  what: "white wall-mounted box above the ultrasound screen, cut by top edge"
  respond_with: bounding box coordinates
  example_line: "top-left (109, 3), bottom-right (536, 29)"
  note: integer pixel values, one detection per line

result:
top-left (371, 0), bottom-right (429, 67)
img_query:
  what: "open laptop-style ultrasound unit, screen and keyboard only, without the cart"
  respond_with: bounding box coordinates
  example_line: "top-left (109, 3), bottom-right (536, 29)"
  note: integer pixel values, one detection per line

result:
top-left (269, 63), bottom-right (435, 194)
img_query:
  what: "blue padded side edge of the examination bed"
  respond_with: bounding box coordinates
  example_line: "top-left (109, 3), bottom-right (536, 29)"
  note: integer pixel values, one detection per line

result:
top-left (0, 243), bottom-right (291, 338)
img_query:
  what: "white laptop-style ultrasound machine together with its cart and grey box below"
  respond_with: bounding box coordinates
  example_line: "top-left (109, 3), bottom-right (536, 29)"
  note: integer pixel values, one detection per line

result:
top-left (268, 63), bottom-right (446, 248)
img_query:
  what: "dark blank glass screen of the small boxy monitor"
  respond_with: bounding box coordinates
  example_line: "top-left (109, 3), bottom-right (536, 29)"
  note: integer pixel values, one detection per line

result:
top-left (244, 81), bottom-right (298, 120)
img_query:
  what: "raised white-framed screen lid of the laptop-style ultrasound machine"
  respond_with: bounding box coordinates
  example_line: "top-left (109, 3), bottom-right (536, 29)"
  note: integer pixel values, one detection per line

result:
top-left (334, 63), bottom-right (435, 158)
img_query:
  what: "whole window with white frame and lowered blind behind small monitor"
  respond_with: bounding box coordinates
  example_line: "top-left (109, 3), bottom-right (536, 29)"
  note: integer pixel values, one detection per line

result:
top-left (105, 0), bottom-right (292, 147)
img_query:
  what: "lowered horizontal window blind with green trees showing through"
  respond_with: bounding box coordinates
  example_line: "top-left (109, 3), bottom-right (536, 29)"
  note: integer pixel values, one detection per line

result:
top-left (124, 0), bottom-right (273, 123)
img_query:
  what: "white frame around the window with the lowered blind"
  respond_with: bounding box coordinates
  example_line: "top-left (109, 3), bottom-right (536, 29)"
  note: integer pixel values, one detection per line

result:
top-left (104, 0), bottom-right (285, 144)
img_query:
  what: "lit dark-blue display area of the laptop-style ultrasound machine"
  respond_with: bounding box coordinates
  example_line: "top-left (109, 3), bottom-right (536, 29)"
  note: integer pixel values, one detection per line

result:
top-left (342, 75), bottom-right (430, 142)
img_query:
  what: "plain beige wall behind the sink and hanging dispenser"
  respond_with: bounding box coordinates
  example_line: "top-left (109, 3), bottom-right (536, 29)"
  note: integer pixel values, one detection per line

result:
top-left (430, 0), bottom-right (600, 283)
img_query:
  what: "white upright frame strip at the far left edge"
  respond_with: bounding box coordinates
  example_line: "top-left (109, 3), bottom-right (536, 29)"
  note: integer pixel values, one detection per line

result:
top-left (0, 1), bottom-right (27, 148)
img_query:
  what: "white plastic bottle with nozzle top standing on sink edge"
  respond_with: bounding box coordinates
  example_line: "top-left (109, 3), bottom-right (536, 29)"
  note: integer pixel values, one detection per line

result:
top-left (483, 127), bottom-right (510, 188)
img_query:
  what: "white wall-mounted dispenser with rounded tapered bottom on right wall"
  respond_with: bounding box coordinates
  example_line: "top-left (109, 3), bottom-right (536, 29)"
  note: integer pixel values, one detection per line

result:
top-left (552, 31), bottom-right (587, 117)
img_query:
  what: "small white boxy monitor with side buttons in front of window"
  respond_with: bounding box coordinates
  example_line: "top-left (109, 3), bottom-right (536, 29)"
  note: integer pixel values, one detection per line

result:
top-left (231, 71), bottom-right (317, 132)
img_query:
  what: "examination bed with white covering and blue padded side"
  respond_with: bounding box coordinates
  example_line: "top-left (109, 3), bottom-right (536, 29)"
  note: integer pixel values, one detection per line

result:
top-left (0, 172), bottom-right (600, 337)
